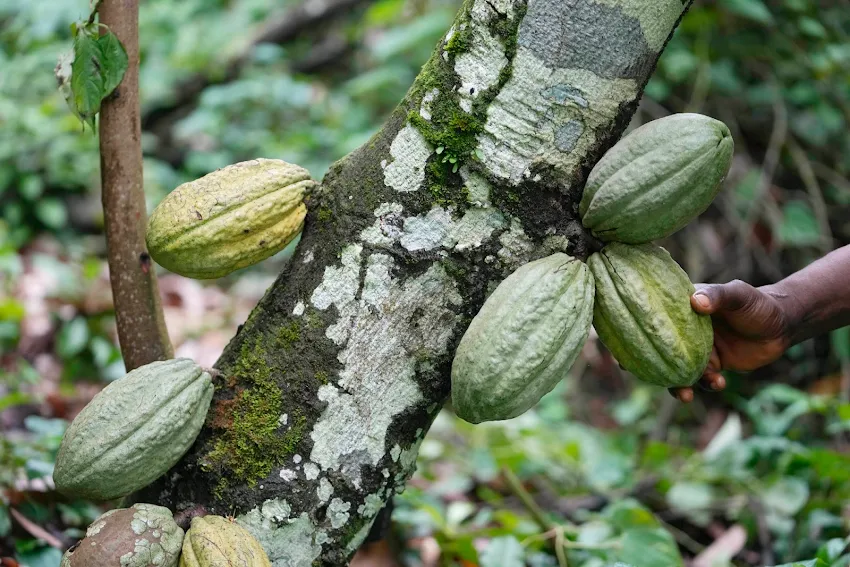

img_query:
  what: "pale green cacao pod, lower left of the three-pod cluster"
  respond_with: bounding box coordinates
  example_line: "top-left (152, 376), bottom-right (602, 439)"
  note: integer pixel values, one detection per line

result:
top-left (452, 253), bottom-right (594, 423)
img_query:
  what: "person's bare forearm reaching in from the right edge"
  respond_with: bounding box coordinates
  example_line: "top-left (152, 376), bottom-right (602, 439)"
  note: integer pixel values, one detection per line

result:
top-left (762, 246), bottom-right (850, 344)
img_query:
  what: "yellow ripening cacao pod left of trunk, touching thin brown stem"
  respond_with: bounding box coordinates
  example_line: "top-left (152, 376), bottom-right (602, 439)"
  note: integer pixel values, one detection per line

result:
top-left (146, 159), bottom-right (316, 279)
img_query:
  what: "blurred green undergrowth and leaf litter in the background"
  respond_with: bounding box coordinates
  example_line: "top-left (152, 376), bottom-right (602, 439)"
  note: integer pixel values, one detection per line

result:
top-left (0, 0), bottom-right (850, 567)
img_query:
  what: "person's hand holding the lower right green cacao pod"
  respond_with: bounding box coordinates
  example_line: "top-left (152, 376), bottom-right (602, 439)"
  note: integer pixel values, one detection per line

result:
top-left (670, 280), bottom-right (791, 403)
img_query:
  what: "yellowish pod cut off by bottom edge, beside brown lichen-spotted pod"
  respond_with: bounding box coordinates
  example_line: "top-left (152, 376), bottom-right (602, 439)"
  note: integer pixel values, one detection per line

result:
top-left (180, 516), bottom-right (271, 567)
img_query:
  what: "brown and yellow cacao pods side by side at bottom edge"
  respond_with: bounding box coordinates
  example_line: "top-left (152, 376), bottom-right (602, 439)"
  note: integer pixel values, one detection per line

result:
top-left (60, 504), bottom-right (271, 567)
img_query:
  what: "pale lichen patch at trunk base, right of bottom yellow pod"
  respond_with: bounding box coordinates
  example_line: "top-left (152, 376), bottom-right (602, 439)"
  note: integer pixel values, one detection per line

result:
top-left (236, 508), bottom-right (328, 567)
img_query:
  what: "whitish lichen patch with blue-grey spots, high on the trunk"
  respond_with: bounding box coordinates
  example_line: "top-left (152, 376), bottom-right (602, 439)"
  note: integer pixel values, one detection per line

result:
top-left (477, 46), bottom-right (638, 184)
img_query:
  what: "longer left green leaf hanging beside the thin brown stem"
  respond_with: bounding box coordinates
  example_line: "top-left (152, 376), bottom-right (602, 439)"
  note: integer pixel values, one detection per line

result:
top-left (71, 27), bottom-right (105, 129)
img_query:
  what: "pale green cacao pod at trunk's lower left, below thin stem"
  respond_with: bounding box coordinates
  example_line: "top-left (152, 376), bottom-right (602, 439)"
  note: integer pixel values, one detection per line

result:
top-left (53, 358), bottom-right (213, 500)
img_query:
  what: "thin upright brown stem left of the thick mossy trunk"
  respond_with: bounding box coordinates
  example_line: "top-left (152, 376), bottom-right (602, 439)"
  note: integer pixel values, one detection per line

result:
top-left (98, 0), bottom-right (174, 371)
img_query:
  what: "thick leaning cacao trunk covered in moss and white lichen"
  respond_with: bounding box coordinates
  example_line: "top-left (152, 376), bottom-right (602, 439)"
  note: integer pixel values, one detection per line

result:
top-left (137, 0), bottom-right (686, 567)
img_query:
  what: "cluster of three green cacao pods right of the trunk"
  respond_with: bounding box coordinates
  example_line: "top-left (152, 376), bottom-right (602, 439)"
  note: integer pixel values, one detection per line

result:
top-left (452, 113), bottom-right (733, 423)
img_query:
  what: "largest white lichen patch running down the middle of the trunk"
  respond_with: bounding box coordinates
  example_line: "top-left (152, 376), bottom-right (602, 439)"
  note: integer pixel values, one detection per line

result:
top-left (310, 265), bottom-right (462, 486)
